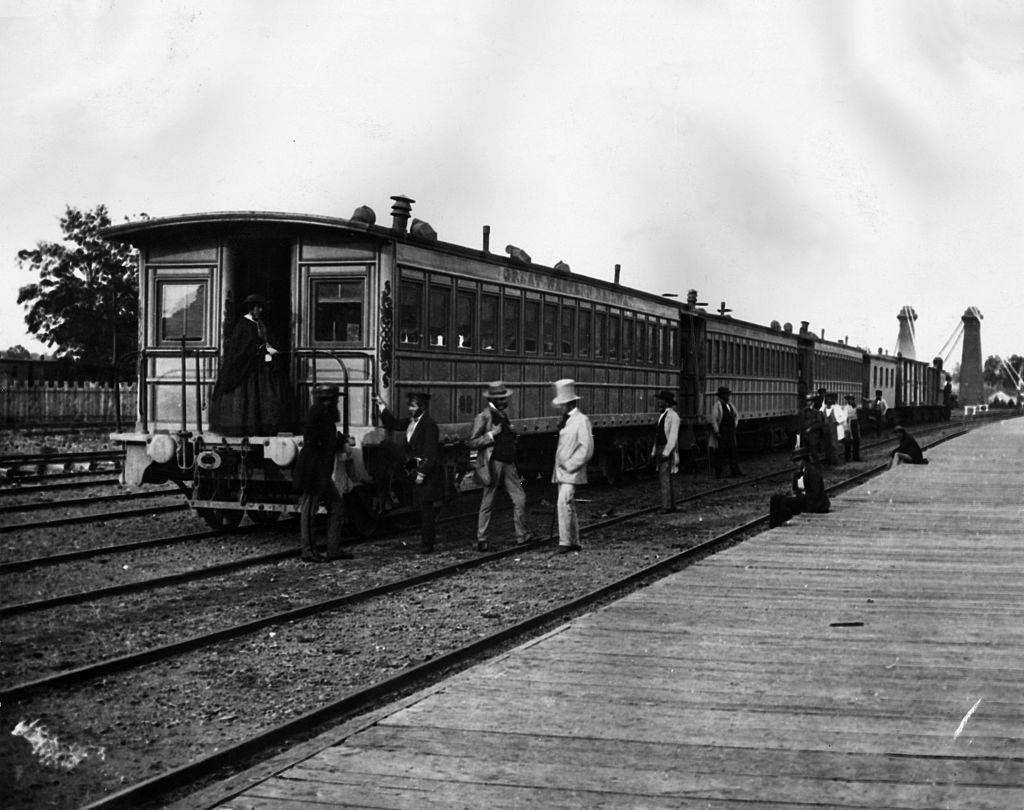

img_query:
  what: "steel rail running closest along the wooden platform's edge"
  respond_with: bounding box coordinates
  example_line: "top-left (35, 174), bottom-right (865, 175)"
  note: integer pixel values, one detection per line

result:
top-left (82, 431), bottom-right (967, 810)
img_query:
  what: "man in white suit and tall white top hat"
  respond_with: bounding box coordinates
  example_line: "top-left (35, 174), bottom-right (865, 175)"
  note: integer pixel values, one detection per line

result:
top-left (551, 380), bottom-right (594, 554)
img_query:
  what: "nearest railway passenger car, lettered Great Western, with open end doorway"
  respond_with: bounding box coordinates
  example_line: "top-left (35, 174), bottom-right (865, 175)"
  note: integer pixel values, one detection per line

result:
top-left (104, 196), bottom-right (679, 528)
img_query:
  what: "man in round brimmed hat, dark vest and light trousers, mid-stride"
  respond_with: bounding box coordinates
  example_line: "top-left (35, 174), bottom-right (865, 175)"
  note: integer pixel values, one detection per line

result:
top-left (468, 380), bottom-right (532, 551)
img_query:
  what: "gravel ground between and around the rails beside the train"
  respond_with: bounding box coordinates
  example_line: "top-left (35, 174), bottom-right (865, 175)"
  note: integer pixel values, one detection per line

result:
top-left (0, 428), bottom-right (950, 808)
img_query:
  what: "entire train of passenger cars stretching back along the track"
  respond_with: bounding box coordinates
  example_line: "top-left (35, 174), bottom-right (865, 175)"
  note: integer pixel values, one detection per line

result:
top-left (102, 195), bottom-right (948, 531)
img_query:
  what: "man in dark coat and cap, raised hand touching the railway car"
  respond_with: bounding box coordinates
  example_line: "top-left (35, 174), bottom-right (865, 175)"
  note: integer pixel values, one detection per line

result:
top-left (377, 391), bottom-right (444, 554)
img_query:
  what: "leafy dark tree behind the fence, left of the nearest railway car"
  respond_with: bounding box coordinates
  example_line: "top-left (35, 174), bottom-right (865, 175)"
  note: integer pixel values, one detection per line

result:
top-left (17, 205), bottom-right (138, 376)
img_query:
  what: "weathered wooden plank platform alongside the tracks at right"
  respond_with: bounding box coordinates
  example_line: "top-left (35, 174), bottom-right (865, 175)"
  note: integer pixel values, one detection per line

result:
top-left (209, 419), bottom-right (1024, 810)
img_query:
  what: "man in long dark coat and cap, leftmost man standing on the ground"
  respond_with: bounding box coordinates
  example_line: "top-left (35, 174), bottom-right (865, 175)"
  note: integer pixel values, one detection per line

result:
top-left (292, 385), bottom-right (352, 562)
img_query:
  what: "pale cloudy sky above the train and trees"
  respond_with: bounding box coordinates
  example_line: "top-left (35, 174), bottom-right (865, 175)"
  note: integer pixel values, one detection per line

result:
top-left (0, 0), bottom-right (1024, 365)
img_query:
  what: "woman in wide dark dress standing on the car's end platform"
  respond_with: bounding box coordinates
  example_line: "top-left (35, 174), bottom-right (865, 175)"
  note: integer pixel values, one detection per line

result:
top-left (210, 295), bottom-right (292, 436)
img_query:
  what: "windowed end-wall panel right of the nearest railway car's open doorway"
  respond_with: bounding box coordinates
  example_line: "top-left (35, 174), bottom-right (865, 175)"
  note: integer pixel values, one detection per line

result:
top-left (296, 262), bottom-right (374, 432)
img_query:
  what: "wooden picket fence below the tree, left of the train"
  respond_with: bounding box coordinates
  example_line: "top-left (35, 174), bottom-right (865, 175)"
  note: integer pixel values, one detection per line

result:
top-left (0, 380), bottom-right (137, 427)
